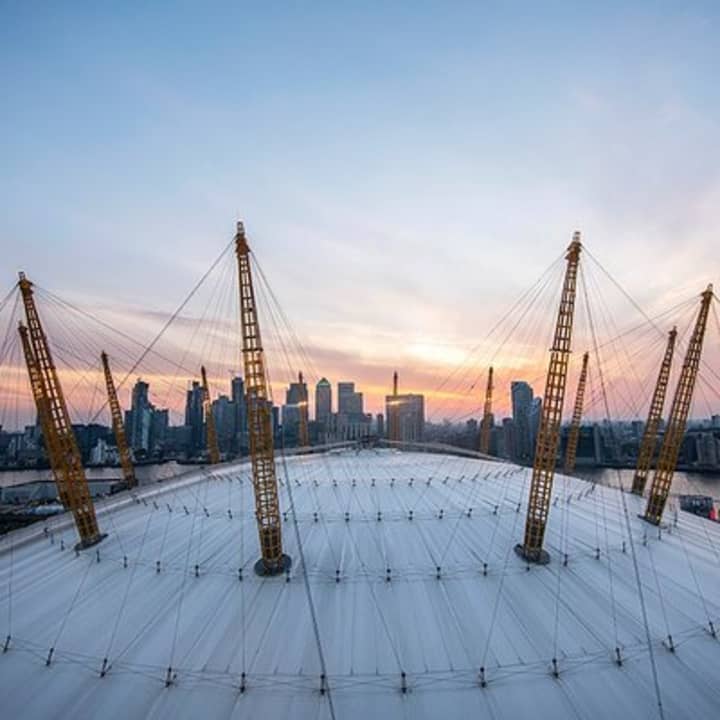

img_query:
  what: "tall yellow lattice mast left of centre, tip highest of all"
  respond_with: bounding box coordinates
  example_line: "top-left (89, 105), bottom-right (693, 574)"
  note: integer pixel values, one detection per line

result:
top-left (235, 222), bottom-right (292, 575)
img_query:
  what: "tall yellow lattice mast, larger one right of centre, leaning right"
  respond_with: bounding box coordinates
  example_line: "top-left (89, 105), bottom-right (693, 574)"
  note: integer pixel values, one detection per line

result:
top-left (515, 232), bottom-right (582, 564)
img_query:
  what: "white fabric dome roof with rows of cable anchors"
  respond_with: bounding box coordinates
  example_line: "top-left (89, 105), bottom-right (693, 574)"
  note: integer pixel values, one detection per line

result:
top-left (0, 450), bottom-right (720, 720)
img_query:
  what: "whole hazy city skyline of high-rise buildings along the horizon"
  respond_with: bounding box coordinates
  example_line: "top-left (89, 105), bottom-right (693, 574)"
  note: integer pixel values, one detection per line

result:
top-left (0, 368), bottom-right (720, 471)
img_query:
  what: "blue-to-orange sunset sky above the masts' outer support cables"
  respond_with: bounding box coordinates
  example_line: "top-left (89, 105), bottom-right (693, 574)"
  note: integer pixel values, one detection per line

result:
top-left (0, 0), bottom-right (720, 422)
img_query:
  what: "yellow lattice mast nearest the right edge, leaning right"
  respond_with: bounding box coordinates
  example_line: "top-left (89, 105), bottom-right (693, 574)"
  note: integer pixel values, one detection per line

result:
top-left (644, 285), bottom-right (713, 525)
